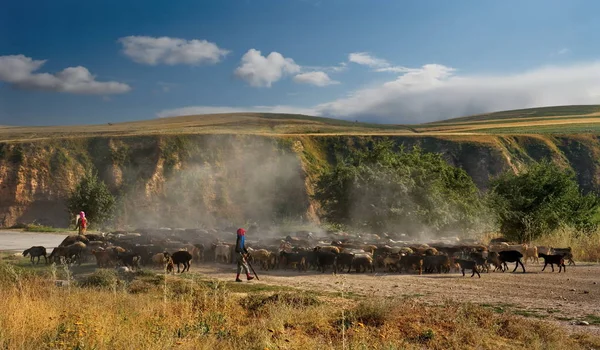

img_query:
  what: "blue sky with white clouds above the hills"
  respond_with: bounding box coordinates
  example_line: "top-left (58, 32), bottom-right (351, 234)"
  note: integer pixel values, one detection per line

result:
top-left (0, 0), bottom-right (600, 125)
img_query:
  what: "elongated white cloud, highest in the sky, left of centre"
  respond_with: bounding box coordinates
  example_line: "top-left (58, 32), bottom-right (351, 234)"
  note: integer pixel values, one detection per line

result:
top-left (119, 36), bottom-right (229, 66)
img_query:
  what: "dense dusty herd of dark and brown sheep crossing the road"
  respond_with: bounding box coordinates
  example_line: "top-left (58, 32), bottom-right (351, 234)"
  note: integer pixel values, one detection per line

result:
top-left (23, 229), bottom-right (575, 277)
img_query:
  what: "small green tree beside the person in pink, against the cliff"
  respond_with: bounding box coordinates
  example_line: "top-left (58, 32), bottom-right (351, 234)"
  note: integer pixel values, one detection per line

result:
top-left (67, 171), bottom-right (115, 225)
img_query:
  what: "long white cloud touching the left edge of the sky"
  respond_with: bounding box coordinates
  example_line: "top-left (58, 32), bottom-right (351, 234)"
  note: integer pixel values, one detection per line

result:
top-left (0, 55), bottom-right (131, 95)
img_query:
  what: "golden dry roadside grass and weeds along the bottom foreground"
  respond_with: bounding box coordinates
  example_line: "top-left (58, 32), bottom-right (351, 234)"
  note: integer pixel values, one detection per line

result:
top-left (0, 261), bottom-right (600, 349)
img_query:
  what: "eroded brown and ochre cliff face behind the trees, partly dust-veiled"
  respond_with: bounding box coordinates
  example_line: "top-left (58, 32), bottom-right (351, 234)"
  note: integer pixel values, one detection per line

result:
top-left (0, 135), bottom-right (600, 227)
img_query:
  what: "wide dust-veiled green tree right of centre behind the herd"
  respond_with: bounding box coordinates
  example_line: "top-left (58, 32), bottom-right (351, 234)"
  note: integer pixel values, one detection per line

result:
top-left (314, 141), bottom-right (483, 232)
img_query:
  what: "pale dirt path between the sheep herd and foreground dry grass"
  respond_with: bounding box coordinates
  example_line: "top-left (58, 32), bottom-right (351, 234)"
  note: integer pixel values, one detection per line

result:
top-left (192, 263), bottom-right (600, 334)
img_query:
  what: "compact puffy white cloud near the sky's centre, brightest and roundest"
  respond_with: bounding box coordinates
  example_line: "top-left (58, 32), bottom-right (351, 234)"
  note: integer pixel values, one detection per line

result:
top-left (235, 49), bottom-right (300, 87)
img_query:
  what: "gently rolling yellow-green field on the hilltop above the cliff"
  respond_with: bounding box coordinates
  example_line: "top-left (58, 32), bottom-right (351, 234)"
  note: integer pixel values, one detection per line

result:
top-left (0, 105), bottom-right (600, 142)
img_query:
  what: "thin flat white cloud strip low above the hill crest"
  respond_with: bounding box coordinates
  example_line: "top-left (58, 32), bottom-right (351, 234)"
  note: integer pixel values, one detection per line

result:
top-left (157, 106), bottom-right (317, 118)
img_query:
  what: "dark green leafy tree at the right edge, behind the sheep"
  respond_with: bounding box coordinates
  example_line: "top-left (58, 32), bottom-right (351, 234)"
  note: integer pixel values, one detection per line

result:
top-left (489, 160), bottom-right (600, 242)
